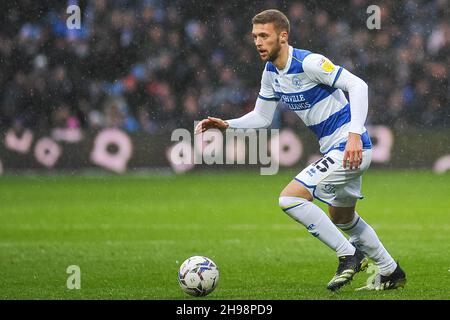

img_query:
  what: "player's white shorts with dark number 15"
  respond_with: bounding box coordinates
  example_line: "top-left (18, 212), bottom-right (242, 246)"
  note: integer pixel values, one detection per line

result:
top-left (294, 149), bottom-right (372, 208)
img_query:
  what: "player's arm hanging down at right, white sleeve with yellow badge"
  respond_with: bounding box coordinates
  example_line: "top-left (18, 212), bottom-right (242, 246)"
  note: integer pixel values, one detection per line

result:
top-left (303, 54), bottom-right (369, 169)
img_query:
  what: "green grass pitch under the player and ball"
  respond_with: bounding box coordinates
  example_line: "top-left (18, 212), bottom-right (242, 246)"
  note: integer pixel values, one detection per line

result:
top-left (0, 170), bottom-right (450, 300)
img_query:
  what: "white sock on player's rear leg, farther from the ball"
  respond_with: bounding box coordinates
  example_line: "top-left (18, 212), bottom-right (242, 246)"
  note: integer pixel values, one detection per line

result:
top-left (336, 212), bottom-right (397, 276)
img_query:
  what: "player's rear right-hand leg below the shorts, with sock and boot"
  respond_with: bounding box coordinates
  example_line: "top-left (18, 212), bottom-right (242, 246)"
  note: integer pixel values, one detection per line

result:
top-left (328, 206), bottom-right (406, 289)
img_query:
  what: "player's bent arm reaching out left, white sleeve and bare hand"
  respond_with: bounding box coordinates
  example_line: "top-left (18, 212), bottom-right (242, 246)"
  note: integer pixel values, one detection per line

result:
top-left (195, 70), bottom-right (279, 133)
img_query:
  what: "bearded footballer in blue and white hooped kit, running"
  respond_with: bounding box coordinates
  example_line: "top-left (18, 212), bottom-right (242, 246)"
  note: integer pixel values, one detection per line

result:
top-left (195, 10), bottom-right (406, 291)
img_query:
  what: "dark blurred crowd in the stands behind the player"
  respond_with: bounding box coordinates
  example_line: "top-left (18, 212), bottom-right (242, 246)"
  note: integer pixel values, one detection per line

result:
top-left (0, 0), bottom-right (450, 134)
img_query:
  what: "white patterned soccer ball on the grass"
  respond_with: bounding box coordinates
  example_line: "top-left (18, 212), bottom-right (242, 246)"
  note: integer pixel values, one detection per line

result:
top-left (178, 256), bottom-right (219, 297)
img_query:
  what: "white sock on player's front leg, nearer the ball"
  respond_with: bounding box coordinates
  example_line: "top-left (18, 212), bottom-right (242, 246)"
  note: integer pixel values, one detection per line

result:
top-left (279, 197), bottom-right (355, 257)
